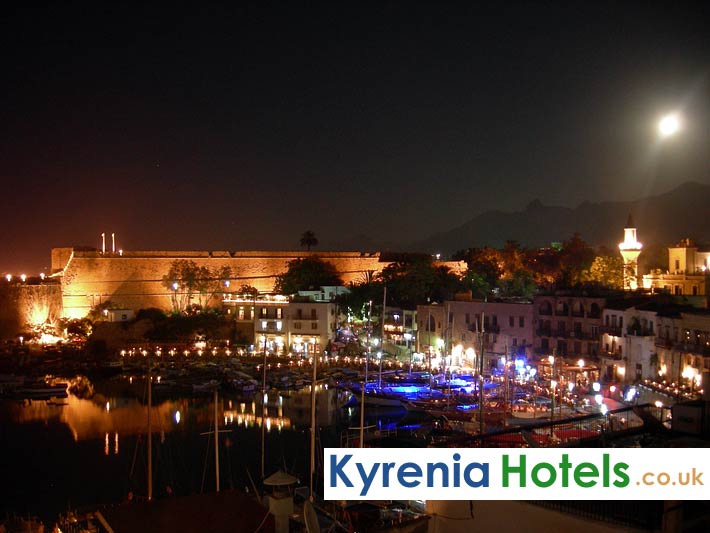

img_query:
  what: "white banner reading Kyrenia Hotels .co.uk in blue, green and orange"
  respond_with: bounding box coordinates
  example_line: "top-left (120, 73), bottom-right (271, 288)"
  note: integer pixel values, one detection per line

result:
top-left (325, 448), bottom-right (710, 500)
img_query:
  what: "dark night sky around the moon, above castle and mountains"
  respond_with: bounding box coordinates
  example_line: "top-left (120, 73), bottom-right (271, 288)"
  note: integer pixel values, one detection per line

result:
top-left (0, 1), bottom-right (710, 274)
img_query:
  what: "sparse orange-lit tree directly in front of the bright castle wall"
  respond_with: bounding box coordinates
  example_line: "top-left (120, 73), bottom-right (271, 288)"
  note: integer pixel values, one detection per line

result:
top-left (162, 259), bottom-right (232, 312)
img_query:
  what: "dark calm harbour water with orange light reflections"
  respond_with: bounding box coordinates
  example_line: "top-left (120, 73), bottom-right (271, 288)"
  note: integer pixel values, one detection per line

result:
top-left (0, 384), bottom-right (356, 524)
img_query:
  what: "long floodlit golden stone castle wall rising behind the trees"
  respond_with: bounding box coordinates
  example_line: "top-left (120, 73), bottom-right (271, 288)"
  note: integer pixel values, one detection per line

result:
top-left (52, 248), bottom-right (464, 318)
